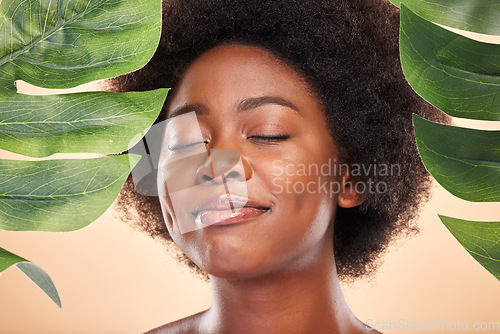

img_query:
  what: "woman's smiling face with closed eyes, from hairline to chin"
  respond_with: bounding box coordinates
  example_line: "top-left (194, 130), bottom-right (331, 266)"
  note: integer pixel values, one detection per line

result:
top-left (160, 44), bottom-right (358, 278)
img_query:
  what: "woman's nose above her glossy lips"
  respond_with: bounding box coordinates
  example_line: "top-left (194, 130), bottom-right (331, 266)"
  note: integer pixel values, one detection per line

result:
top-left (196, 149), bottom-right (253, 184)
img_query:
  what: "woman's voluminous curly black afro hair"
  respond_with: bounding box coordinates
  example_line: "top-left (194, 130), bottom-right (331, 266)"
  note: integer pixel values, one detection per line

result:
top-left (112, 0), bottom-right (447, 280)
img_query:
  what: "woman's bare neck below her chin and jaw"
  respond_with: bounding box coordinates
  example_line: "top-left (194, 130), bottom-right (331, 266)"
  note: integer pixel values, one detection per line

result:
top-left (202, 240), bottom-right (365, 333)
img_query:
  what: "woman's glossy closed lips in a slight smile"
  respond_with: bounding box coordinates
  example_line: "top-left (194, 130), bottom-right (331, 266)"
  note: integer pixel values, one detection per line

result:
top-left (190, 194), bottom-right (270, 226)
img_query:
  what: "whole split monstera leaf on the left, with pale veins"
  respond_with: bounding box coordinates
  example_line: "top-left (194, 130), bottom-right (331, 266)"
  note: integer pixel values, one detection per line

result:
top-left (0, 0), bottom-right (167, 306)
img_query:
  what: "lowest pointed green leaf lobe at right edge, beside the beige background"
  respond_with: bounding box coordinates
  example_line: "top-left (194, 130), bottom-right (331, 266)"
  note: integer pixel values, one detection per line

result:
top-left (439, 215), bottom-right (500, 280)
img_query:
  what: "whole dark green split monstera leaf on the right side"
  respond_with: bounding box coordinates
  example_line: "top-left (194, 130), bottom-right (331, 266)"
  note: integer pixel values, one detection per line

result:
top-left (400, 0), bottom-right (500, 279)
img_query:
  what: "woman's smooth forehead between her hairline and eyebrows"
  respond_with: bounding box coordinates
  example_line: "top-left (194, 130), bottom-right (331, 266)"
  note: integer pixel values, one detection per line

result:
top-left (164, 44), bottom-right (319, 115)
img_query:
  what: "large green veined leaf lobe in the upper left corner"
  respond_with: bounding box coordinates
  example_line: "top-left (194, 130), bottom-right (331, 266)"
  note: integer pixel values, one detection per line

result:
top-left (0, 0), bottom-right (161, 91)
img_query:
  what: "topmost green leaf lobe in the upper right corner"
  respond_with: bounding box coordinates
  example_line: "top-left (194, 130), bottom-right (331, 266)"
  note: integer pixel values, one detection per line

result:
top-left (391, 0), bottom-right (500, 35)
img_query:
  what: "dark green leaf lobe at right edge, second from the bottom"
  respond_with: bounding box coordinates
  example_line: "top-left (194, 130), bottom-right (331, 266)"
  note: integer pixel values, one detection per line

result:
top-left (413, 115), bottom-right (500, 202)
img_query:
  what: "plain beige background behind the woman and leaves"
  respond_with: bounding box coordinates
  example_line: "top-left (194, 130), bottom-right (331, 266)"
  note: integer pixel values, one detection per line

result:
top-left (0, 25), bottom-right (500, 333)
